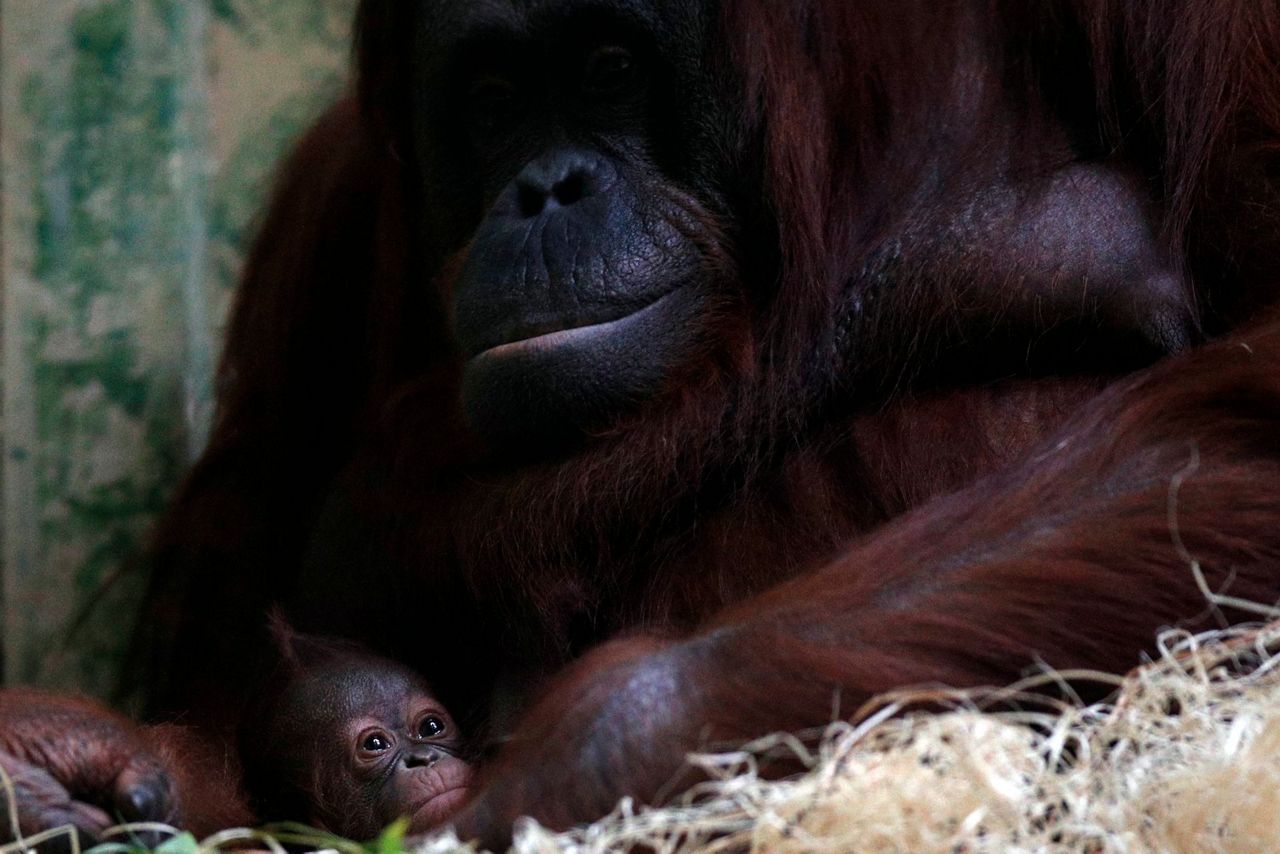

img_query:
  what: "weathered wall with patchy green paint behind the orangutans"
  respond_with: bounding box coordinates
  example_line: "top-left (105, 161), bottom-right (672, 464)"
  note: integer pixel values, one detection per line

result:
top-left (0, 0), bottom-right (355, 693)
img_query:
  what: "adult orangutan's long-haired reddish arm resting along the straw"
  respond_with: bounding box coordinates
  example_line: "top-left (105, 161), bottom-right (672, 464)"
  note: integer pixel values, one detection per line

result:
top-left (463, 313), bottom-right (1280, 832)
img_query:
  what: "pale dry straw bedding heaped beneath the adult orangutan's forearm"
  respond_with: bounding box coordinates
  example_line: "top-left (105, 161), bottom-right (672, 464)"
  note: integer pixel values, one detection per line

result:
top-left (429, 624), bottom-right (1280, 854)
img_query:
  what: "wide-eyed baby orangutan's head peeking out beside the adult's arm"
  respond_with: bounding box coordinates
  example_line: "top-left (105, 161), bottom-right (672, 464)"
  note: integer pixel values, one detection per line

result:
top-left (239, 618), bottom-right (471, 840)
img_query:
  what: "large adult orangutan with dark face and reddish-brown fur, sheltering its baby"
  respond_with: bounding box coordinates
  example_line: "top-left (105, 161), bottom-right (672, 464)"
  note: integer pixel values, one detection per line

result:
top-left (0, 0), bottom-right (1280, 841)
